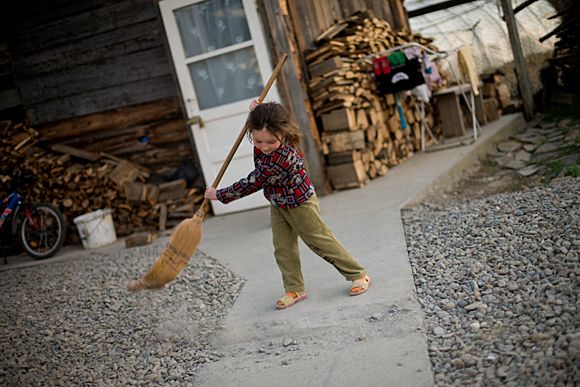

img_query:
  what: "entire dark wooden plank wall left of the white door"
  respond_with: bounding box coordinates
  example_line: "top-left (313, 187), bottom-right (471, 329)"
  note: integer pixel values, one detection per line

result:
top-left (0, 0), bottom-right (194, 174)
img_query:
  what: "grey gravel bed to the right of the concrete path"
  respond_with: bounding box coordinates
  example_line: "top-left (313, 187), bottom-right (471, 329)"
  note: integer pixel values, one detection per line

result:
top-left (403, 177), bottom-right (580, 386)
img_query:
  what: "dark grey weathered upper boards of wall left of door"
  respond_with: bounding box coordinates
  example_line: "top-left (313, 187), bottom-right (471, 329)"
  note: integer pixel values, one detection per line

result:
top-left (0, 0), bottom-right (177, 125)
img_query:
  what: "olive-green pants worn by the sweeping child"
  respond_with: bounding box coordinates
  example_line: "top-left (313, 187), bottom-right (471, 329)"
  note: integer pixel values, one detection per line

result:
top-left (270, 195), bottom-right (366, 292)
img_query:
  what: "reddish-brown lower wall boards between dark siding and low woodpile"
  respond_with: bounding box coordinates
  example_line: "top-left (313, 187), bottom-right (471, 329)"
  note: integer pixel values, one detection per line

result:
top-left (35, 98), bottom-right (192, 172)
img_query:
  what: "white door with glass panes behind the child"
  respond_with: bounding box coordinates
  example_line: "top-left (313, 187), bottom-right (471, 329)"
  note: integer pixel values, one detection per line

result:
top-left (159, 0), bottom-right (279, 215)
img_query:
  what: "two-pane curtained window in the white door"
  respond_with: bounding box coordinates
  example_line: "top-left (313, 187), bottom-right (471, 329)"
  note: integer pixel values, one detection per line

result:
top-left (174, 0), bottom-right (263, 110)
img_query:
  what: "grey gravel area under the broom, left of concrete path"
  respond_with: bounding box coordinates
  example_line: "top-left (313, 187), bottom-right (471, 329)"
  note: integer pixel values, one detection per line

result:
top-left (0, 244), bottom-right (244, 386)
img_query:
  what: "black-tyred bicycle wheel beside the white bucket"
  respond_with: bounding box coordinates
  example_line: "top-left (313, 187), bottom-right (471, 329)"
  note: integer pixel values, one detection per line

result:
top-left (18, 204), bottom-right (66, 259)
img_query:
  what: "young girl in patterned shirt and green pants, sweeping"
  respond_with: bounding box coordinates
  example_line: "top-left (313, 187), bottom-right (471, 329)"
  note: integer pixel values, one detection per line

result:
top-left (204, 101), bottom-right (371, 309)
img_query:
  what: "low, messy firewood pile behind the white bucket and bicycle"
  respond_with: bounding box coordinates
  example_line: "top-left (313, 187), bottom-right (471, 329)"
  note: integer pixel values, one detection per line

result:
top-left (0, 121), bottom-right (203, 243)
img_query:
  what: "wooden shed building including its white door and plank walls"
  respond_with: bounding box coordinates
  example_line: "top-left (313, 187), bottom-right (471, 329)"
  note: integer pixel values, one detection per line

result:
top-left (0, 0), bottom-right (408, 218)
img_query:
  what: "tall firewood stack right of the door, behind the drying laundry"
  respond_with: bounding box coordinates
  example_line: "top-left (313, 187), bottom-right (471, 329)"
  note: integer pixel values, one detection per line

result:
top-left (305, 12), bottom-right (435, 189)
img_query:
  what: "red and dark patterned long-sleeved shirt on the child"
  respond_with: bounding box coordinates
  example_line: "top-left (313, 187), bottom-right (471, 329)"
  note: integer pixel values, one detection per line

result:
top-left (217, 145), bottom-right (314, 208)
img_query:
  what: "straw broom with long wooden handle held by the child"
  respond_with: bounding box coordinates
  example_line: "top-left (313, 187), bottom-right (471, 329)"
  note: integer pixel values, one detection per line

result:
top-left (127, 54), bottom-right (288, 292)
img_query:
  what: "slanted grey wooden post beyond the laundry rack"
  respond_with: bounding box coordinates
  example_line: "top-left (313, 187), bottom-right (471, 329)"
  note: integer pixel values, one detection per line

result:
top-left (501, 0), bottom-right (534, 120)
